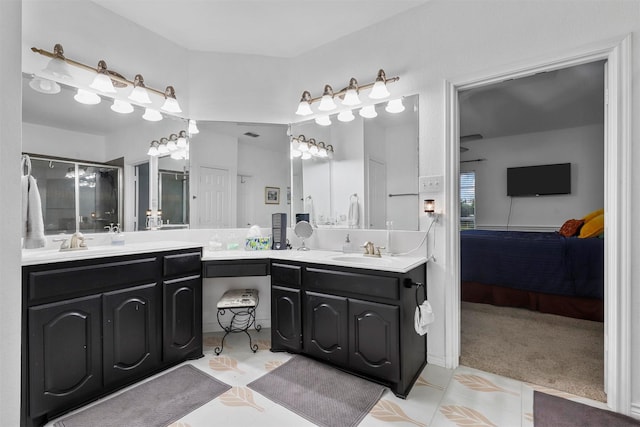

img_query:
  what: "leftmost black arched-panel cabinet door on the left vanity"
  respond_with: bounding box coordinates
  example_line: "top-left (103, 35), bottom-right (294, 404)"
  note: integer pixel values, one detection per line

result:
top-left (28, 295), bottom-right (102, 417)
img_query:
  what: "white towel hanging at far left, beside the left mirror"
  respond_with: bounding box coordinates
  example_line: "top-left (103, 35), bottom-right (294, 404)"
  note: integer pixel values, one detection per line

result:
top-left (21, 175), bottom-right (47, 249)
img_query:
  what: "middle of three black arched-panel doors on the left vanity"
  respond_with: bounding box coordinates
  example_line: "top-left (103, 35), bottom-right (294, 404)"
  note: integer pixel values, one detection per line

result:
top-left (102, 283), bottom-right (160, 386)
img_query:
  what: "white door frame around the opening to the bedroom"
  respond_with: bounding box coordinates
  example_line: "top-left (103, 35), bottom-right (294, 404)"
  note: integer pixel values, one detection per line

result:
top-left (444, 36), bottom-right (632, 414)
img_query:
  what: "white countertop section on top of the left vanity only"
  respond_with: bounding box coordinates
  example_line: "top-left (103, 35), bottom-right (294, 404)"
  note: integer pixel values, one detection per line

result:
top-left (22, 240), bottom-right (202, 265)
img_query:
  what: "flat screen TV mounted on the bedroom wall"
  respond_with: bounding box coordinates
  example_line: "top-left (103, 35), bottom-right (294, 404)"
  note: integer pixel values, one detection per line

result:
top-left (507, 163), bottom-right (571, 197)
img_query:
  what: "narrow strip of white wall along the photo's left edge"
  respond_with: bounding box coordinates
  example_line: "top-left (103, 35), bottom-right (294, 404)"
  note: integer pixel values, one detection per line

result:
top-left (0, 0), bottom-right (22, 426)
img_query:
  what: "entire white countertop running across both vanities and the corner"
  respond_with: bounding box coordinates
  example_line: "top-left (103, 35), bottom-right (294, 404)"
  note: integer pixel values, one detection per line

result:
top-left (22, 240), bottom-right (427, 273)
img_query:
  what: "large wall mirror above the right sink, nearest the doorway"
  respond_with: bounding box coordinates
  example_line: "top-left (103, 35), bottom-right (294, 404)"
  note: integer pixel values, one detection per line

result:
top-left (291, 95), bottom-right (419, 230)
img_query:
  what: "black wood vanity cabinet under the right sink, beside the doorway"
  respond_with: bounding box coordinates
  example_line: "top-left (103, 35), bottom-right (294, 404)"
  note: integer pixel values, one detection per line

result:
top-left (271, 261), bottom-right (427, 398)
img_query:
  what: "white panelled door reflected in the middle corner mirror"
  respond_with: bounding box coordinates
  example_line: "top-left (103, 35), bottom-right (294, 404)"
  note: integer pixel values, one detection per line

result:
top-left (198, 166), bottom-right (230, 228)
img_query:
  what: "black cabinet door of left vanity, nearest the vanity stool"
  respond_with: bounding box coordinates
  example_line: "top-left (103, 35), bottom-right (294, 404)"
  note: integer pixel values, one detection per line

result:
top-left (162, 276), bottom-right (202, 362)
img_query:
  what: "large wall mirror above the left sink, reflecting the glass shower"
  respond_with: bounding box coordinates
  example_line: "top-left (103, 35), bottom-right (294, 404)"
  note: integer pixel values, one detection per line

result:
top-left (22, 74), bottom-right (189, 233)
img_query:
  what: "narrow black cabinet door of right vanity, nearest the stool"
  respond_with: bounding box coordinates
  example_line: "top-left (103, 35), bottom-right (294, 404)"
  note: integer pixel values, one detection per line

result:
top-left (271, 286), bottom-right (302, 352)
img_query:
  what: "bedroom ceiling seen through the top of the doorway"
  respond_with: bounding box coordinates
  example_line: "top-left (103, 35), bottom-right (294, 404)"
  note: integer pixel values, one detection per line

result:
top-left (459, 61), bottom-right (604, 143)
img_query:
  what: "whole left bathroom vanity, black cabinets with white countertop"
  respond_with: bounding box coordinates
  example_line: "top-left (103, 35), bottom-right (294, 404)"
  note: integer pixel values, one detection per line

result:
top-left (22, 243), bottom-right (202, 426)
